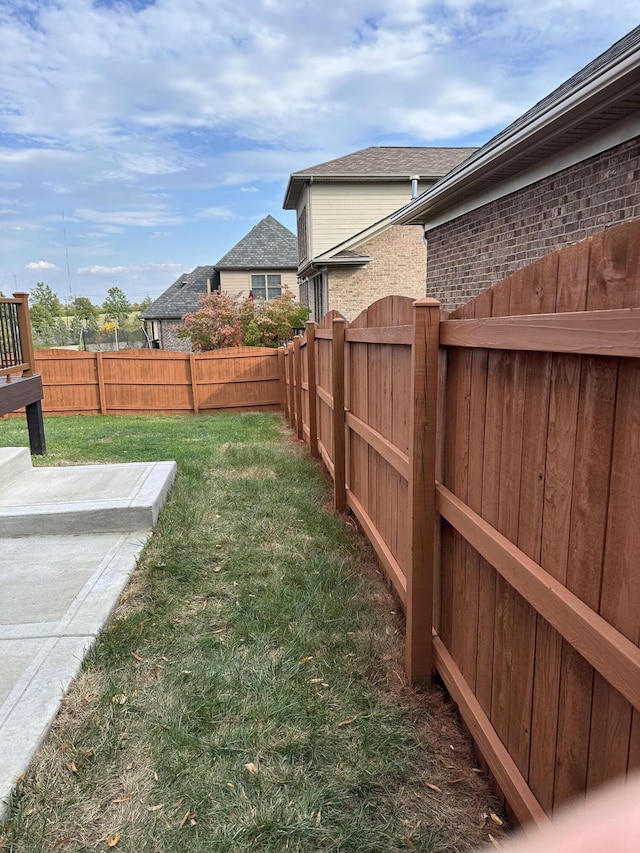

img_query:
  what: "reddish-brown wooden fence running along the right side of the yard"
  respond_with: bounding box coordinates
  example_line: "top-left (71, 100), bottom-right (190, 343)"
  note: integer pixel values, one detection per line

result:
top-left (283, 222), bottom-right (640, 825)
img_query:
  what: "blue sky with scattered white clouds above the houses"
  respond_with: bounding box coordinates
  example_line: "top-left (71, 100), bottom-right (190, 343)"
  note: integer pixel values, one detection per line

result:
top-left (0, 0), bottom-right (640, 304)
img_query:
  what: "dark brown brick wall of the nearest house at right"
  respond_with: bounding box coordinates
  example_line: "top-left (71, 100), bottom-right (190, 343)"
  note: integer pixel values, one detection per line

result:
top-left (427, 138), bottom-right (640, 311)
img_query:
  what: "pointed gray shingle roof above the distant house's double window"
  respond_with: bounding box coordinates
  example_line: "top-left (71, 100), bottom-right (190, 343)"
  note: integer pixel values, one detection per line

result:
top-left (216, 216), bottom-right (298, 270)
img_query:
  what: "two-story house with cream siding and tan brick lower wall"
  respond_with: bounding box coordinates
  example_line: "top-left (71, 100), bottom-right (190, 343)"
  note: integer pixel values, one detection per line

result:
top-left (283, 146), bottom-right (475, 320)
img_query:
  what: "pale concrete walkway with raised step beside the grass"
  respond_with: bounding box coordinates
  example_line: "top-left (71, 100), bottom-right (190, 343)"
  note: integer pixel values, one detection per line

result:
top-left (0, 448), bottom-right (176, 816)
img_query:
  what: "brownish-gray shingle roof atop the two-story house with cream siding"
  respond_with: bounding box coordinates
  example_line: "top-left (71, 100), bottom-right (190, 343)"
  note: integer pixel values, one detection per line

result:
top-left (283, 145), bottom-right (476, 210)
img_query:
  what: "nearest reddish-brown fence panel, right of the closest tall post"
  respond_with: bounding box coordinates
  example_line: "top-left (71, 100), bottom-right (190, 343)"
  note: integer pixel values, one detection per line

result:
top-left (439, 216), bottom-right (640, 821)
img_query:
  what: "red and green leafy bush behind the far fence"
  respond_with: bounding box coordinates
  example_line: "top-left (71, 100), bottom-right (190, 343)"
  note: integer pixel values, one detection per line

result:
top-left (176, 291), bottom-right (309, 352)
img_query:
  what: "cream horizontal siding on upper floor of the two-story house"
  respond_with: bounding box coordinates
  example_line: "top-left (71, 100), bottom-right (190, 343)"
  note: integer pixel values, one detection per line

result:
top-left (308, 183), bottom-right (420, 257)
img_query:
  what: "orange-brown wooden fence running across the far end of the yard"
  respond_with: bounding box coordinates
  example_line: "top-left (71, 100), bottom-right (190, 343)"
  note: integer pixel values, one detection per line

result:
top-left (20, 347), bottom-right (281, 415)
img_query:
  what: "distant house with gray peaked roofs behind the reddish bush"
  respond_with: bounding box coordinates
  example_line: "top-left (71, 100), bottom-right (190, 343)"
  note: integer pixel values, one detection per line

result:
top-left (140, 216), bottom-right (298, 352)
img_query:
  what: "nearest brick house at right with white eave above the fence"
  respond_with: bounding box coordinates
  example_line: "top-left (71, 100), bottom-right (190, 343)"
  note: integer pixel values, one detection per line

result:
top-left (392, 27), bottom-right (640, 310)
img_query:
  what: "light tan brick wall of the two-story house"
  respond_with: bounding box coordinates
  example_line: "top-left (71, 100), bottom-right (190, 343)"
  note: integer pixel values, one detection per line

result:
top-left (329, 225), bottom-right (427, 320)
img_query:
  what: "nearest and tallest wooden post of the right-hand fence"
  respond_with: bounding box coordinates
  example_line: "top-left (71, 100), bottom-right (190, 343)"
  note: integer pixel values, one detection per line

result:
top-left (405, 298), bottom-right (440, 685)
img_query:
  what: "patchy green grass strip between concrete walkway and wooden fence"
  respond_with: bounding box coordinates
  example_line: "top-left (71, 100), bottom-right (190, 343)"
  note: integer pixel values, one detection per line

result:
top-left (0, 415), bottom-right (499, 853)
